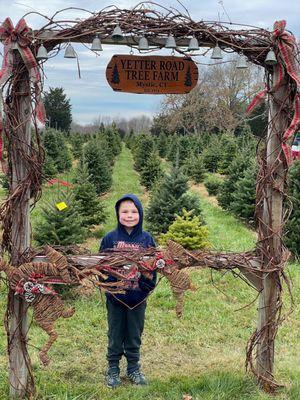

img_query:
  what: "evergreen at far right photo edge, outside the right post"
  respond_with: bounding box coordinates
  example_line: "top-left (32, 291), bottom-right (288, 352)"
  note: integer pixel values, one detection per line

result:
top-left (285, 160), bottom-right (300, 258)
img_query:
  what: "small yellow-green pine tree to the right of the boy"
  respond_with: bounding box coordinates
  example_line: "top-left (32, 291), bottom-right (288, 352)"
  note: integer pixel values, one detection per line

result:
top-left (159, 209), bottom-right (210, 250)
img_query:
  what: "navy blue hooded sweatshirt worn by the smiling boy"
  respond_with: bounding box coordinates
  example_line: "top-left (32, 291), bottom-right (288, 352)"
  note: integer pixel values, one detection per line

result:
top-left (100, 193), bottom-right (156, 307)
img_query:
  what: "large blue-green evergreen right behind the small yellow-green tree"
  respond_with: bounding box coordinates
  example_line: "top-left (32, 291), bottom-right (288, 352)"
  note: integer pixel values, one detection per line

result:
top-left (146, 167), bottom-right (201, 235)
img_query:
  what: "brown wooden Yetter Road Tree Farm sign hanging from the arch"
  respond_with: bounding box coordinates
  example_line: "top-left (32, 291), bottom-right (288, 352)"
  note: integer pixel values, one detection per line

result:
top-left (106, 54), bottom-right (198, 94)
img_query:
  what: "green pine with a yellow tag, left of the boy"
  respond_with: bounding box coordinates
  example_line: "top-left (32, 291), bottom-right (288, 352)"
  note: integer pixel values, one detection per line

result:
top-left (34, 193), bottom-right (86, 246)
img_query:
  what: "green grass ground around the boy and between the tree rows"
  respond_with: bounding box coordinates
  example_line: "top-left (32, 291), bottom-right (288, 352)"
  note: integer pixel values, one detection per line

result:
top-left (0, 145), bottom-right (300, 400)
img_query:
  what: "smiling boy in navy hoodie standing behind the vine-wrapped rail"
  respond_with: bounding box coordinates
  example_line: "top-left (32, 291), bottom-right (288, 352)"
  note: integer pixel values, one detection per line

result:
top-left (100, 194), bottom-right (156, 388)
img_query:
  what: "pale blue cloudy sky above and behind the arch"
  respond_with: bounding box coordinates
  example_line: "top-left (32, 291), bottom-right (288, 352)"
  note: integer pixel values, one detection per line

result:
top-left (0, 0), bottom-right (300, 125)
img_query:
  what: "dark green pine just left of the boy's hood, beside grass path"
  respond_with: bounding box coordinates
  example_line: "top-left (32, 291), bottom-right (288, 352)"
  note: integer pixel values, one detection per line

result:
top-left (74, 164), bottom-right (106, 227)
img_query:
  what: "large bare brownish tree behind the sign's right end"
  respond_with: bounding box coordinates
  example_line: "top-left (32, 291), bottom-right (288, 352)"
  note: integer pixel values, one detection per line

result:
top-left (160, 58), bottom-right (263, 133)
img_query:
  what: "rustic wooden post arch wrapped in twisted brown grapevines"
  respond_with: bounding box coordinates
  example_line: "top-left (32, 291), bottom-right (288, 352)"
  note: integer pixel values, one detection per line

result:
top-left (0, 2), bottom-right (300, 397)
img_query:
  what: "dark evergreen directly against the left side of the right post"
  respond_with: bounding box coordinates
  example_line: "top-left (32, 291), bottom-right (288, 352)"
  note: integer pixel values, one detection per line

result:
top-left (230, 161), bottom-right (257, 222)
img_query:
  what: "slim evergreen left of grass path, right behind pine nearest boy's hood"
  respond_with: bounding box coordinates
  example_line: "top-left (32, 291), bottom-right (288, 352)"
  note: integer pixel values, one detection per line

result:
top-left (83, 139), bottom-right (112, 195)
